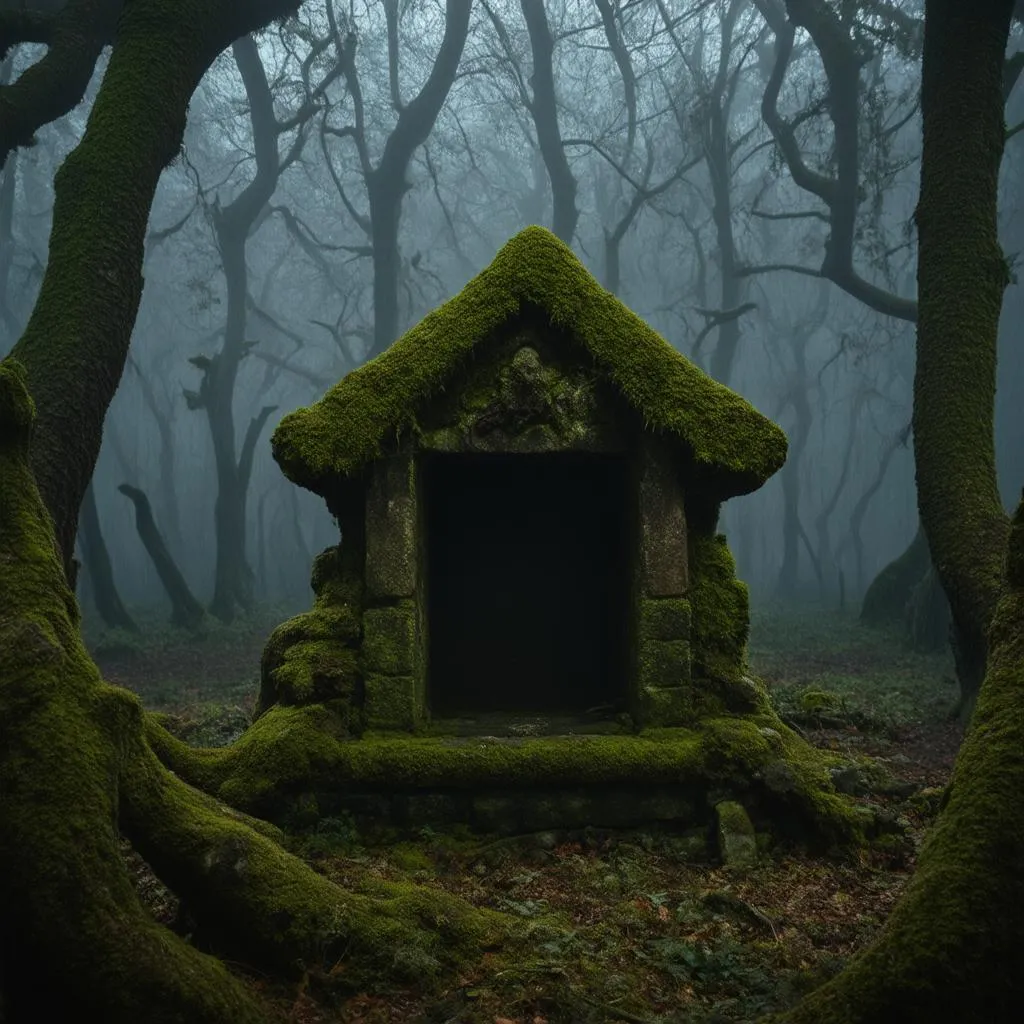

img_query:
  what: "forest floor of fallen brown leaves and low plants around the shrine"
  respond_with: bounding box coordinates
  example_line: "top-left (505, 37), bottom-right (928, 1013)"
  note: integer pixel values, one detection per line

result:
top-left (87, 607), bottom-right (961, 1024)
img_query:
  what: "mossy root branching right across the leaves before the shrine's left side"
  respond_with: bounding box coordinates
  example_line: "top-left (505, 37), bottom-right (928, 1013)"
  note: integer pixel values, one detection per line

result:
top-left (122, 720), bottom-right (506, 982)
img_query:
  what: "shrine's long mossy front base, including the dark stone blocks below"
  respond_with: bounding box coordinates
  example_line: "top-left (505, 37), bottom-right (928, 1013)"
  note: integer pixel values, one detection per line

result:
top-left (148, 705), bottom-right (860, 848)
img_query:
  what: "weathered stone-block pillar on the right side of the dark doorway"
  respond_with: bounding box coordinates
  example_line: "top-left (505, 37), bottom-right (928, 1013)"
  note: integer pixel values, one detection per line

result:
top-left (637, 440), bottom-right (691, 726)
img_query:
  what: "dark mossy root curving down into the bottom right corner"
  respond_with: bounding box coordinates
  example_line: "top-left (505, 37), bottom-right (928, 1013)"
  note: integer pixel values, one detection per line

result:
top-left (778, 502), bottom-right (1024, 1024)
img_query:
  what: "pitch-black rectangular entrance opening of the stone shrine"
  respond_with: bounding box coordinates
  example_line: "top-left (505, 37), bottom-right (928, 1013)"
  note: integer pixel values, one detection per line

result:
top-left (425, 455), bottom-right (630, 718)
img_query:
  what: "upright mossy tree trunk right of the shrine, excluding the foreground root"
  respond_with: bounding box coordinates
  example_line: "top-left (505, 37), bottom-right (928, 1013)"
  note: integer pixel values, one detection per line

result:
top-left (913, 0), bottom-right (1014, 719)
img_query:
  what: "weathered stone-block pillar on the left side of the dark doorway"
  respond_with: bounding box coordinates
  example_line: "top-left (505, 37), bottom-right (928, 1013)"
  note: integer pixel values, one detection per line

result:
top-left (362, 455), bottom-right (425, 731)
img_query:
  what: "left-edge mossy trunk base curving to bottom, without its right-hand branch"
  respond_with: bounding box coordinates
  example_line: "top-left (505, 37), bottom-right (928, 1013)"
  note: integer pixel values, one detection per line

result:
top-left (0, 359), bottom-right (265, 1024)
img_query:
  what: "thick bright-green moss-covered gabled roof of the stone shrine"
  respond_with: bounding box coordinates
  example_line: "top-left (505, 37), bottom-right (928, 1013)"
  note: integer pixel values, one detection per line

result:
top-left (271, 227), bottom-right (786, 496)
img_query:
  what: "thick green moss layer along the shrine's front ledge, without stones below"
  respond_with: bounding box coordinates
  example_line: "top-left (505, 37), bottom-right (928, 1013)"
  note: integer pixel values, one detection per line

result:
top-left (151, 704), bottom-right (858, 845)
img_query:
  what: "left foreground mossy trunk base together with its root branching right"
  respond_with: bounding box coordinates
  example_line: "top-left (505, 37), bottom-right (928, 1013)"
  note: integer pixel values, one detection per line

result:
top-left (0, 359), bottom-right (504, 1024)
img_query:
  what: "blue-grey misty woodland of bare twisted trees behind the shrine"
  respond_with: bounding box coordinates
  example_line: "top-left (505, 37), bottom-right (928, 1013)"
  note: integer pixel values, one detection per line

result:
top-left (0, 0), bottom-right (1024, 612)
